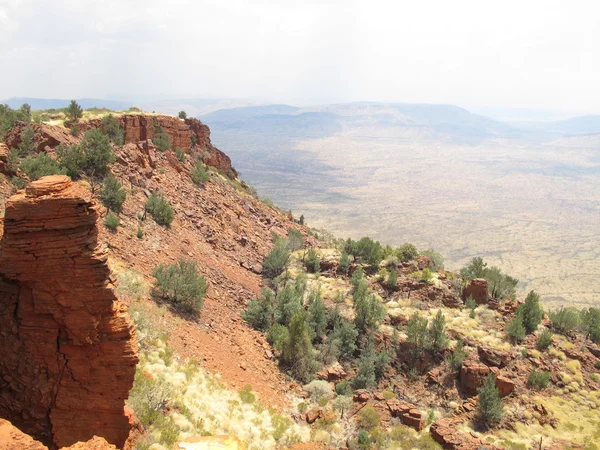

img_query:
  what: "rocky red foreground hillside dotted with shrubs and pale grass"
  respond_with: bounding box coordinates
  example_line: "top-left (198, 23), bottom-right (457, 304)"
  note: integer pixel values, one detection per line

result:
top-left (0, 106), bottom-right (600, 450)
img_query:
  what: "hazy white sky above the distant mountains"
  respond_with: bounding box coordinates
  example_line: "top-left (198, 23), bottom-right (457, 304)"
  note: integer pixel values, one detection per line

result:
top-left (0, 0), bottom-right (600, 112)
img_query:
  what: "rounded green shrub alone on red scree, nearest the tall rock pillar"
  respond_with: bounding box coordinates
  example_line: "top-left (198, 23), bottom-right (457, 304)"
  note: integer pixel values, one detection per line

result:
top-left (152, 258), bottom-right (208, 312)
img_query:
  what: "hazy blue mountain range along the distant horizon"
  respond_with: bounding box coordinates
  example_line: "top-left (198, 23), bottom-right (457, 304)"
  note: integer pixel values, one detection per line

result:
top-left (1, 97), bottom-right (600, 144)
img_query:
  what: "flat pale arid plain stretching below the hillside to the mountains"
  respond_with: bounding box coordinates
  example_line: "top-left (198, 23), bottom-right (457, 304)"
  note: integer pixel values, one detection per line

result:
top-left (214, 124), bottom-right (600, 307)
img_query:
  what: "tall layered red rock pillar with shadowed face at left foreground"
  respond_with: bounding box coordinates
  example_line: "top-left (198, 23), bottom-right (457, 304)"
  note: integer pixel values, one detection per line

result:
top-left (0, 176), bottom-right (138, 447)
